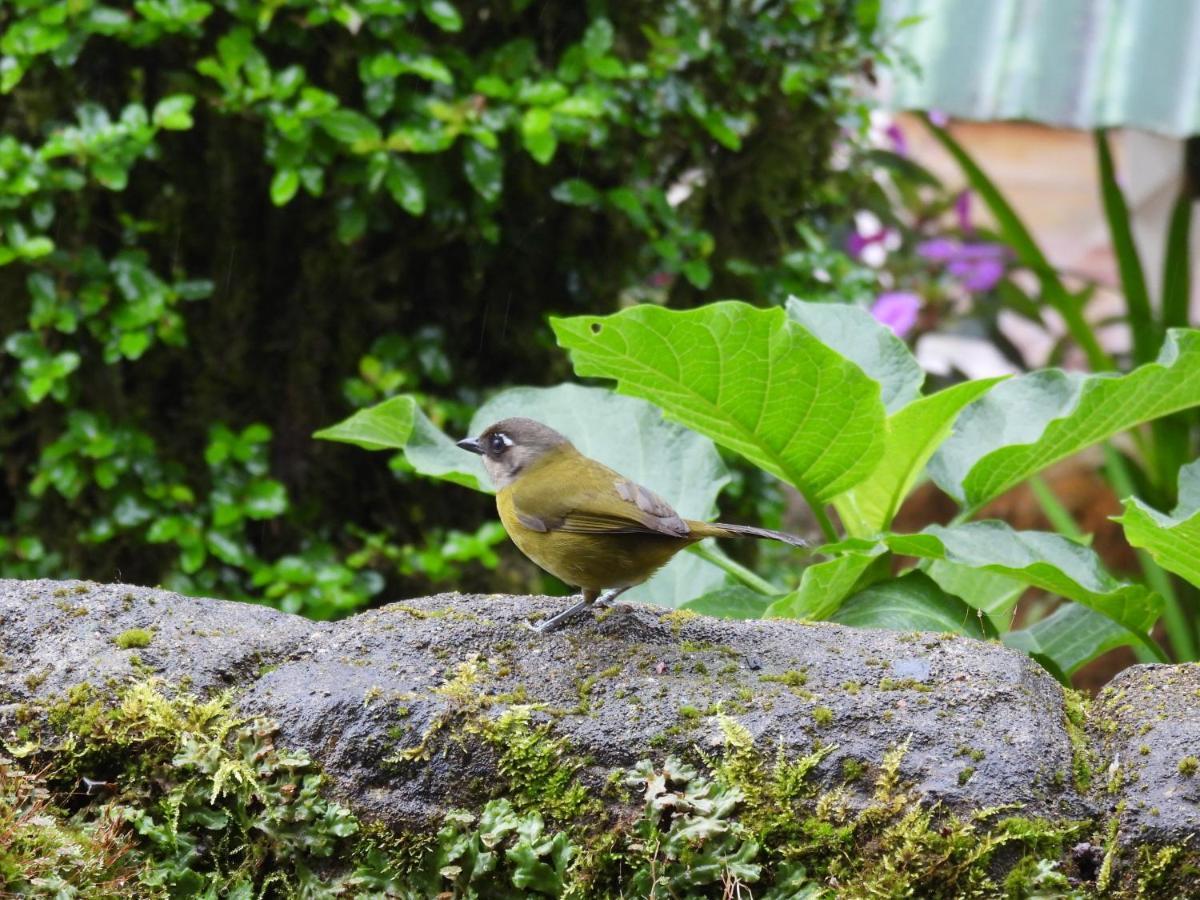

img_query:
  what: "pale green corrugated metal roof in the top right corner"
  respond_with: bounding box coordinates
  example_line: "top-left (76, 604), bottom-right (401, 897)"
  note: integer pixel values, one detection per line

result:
top-left (884, 0), bottom-right (1200, 137)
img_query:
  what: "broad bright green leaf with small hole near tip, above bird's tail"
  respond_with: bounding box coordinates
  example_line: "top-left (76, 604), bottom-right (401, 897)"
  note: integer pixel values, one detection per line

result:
top-left (551, 301), bottom-right (883, 505)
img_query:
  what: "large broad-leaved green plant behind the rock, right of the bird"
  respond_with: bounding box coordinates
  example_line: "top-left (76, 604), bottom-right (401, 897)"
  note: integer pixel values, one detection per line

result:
top-left (553, 300), bottom-right (1200, 673)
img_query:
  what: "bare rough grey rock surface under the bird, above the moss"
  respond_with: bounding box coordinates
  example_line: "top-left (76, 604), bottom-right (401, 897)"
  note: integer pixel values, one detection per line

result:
top-left (0, 581), bottom-right (1099, 834)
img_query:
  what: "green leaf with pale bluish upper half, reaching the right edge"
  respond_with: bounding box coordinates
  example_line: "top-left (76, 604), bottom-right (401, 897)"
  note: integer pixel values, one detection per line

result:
top-left (929, 329), bottom-right (1200, 509)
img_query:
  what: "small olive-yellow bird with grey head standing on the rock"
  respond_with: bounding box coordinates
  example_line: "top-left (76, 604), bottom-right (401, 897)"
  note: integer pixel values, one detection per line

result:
top-left (457, 416), bottom-right (808, 634)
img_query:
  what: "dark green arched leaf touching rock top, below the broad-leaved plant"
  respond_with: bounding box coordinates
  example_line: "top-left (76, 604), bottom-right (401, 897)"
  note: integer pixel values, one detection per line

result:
top-left (830, 572), bottom-right (992, 637)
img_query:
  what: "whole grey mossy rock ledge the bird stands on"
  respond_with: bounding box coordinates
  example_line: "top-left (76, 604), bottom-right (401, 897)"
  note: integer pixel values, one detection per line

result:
top-left (0, 582), bottom-right (1200, 898)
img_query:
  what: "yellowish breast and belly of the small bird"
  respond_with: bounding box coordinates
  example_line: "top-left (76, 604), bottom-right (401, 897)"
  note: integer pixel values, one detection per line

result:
top-left (496, 491), bottom-right (692, 590)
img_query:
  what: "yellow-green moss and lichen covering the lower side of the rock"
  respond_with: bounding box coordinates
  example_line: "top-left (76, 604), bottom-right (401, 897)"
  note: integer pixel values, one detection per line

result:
top-left (0, 681), bottom-right (1123, 900)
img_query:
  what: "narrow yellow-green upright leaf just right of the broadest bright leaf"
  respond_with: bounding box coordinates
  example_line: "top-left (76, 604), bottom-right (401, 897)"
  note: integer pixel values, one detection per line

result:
top-left (834, 378), bottom-right (1001, 536)
